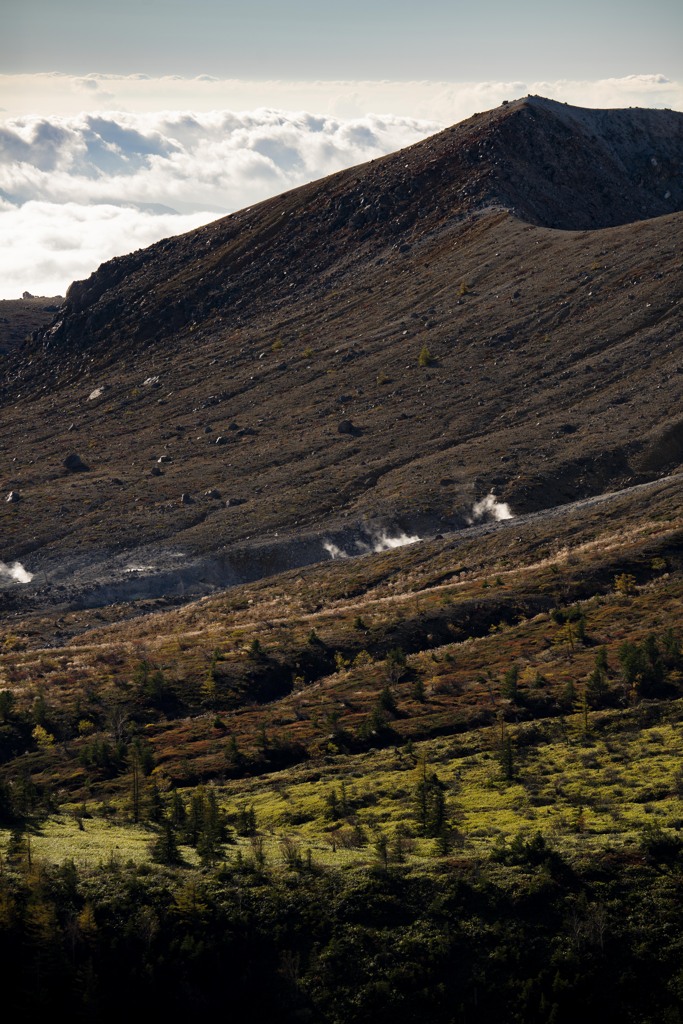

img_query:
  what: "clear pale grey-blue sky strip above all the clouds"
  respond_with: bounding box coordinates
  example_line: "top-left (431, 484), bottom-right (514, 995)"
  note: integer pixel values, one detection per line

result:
top-left (5, 0), bottom-right (683, 81)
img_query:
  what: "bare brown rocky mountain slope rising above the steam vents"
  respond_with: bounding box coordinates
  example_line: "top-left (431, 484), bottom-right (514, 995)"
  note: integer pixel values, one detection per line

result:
top-left (0, 97), bottom-right (683, 601)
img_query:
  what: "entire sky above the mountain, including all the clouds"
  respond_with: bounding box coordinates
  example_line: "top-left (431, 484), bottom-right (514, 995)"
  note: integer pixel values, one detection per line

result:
top-left (0, 0), bottom-right (683, 298)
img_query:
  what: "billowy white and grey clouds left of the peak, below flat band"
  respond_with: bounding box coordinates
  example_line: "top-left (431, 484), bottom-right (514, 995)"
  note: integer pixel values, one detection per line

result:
top-left (0, 110), bottom-right (440, 298)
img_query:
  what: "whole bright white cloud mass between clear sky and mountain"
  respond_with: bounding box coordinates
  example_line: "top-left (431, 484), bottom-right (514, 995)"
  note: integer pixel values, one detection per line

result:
top-left (0, 74), bottom-right (683, 298)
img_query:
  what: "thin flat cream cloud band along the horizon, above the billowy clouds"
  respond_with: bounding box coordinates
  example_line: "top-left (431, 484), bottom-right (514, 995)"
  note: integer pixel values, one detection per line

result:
top-left (0, 72), bottom-right (683, 124)
